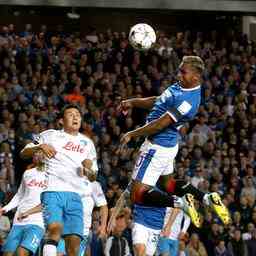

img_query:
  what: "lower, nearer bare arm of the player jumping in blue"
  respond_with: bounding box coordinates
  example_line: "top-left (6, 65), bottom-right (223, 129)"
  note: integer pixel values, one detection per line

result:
top-left (121, 113), bottom-right (174, 145)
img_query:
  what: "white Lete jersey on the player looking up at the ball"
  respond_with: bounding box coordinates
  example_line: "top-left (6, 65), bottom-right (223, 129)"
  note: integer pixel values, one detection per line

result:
top-left (22, 130), bottom-right (98, 194)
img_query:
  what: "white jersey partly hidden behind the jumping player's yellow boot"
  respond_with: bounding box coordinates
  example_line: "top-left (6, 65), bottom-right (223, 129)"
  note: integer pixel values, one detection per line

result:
top-left (164, 207), bottom-right (190, 240)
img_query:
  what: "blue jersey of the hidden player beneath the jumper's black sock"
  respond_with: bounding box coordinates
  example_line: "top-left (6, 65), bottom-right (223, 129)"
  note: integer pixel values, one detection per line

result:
top-left (133, 204), bottom-right (166, 230)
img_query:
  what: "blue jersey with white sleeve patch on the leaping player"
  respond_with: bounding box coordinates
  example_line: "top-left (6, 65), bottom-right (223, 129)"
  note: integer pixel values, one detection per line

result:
top-left (147, 82), bottom-right (201, 147)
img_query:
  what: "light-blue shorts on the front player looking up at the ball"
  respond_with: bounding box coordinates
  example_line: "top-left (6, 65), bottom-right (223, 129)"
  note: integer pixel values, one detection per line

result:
top-left (41, 191), bottom-right (84, 238)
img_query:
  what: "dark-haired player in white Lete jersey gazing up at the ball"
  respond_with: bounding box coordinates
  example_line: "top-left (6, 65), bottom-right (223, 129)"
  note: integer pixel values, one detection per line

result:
top-left (21, 105), bottom-right (98, 256)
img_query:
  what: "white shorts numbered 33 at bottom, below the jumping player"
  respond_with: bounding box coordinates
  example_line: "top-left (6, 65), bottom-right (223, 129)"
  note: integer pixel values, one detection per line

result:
top-left (132, 223), bottom-right (161, 256)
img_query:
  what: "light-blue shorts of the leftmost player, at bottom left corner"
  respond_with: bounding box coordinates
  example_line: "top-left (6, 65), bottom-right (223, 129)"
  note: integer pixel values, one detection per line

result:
top-left (3, 225), bottom-right (44, 254)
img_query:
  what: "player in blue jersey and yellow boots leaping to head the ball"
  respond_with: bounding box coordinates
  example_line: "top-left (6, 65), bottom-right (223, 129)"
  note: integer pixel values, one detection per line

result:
top-left (120, 56), bottom-right (230, 227)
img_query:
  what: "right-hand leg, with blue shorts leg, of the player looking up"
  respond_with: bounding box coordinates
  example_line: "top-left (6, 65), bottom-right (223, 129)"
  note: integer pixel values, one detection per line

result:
top-left (63, 192), bottom-right (84, 256)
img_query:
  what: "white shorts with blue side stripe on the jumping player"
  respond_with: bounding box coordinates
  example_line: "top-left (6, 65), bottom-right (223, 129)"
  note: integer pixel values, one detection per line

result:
top-left (132, 140), bottom-right (179, 186)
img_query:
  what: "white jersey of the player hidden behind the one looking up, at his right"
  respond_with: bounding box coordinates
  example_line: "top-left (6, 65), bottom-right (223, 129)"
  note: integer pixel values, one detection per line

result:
top-left (81, 179), bottom-right (107, 235)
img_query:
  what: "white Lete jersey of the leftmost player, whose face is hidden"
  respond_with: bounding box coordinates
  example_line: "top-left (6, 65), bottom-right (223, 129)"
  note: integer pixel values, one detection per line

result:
top-left (3, 168), bottom-right (47, 228)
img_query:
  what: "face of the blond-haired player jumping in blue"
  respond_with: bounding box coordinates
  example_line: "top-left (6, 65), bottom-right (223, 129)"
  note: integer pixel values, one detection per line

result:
top-left (177, 63), bottom-right (200, 88)
